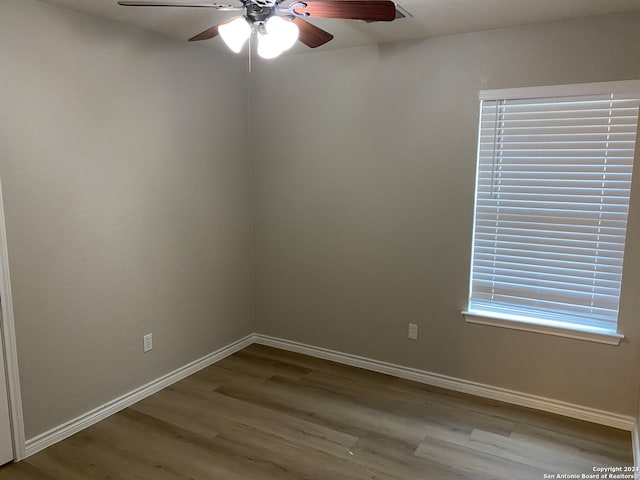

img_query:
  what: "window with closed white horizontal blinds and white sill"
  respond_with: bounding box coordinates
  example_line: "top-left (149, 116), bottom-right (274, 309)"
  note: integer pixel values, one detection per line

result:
top-left (463, 81), bottom-right (640, 344)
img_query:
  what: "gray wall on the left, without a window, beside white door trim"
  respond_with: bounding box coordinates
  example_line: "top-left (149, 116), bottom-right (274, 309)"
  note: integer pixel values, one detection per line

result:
top-left (0, 0), bottom-right (253, 438)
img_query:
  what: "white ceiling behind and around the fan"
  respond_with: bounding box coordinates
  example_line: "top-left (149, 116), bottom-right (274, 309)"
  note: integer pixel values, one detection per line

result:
top-left (40, 0), bottom-right (640, 51)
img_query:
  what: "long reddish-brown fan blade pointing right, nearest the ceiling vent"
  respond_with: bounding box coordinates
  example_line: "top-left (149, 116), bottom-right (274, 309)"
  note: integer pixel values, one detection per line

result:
top-left (294, 0), bottom-right (396, 22)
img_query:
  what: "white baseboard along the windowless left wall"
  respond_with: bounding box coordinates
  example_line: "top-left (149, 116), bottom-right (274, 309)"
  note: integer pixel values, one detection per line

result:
top-left (25, 335), bottom-right (254, 457)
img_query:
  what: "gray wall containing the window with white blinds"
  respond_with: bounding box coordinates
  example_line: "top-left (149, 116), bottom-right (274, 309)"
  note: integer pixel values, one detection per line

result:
top-left (250, 14), bottom-right (640, 415)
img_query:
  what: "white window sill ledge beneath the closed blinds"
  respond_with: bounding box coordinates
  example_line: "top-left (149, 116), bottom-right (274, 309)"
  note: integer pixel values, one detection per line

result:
top-left (462, 311), bottom-right (624, 345)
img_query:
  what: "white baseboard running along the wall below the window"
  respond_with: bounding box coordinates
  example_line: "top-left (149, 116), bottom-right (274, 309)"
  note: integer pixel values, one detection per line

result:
top-left (254, 334), bottom-right (638, 432)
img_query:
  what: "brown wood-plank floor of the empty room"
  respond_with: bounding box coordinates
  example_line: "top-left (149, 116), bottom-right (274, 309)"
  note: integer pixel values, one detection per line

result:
top-left (0, 345), bottom-right (633, 480)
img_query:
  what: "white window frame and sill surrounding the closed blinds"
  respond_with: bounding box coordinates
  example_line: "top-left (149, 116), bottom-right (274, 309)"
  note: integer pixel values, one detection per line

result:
top-left (462, 80), bottom-right (640, 345)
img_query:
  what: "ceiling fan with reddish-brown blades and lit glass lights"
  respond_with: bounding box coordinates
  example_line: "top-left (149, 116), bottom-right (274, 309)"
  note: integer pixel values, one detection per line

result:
top-left (118, 0), bottom-right (396, 58)
